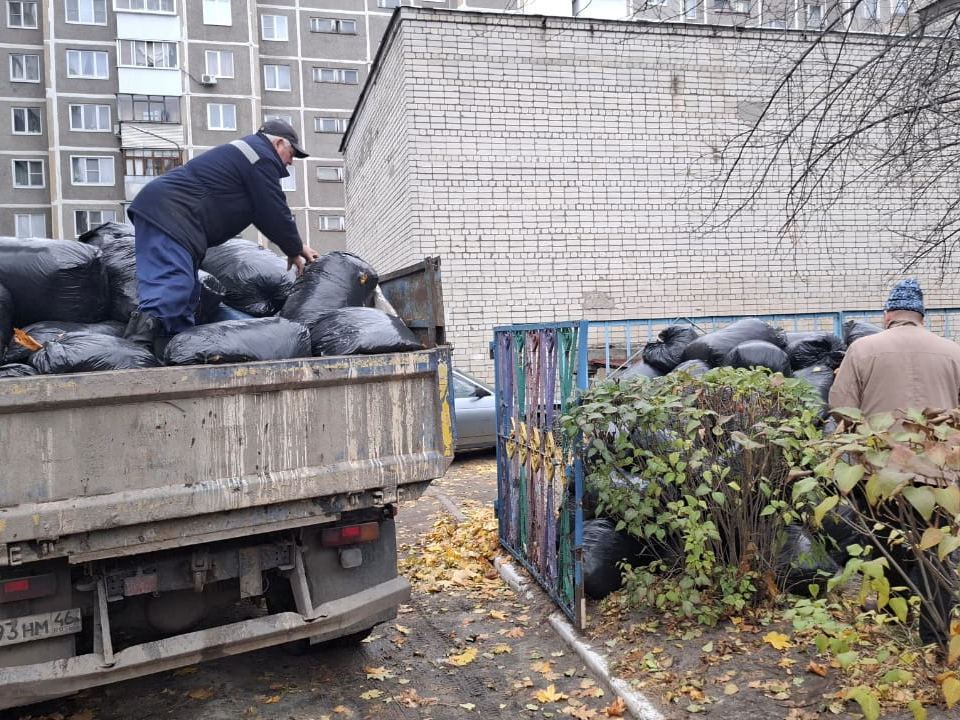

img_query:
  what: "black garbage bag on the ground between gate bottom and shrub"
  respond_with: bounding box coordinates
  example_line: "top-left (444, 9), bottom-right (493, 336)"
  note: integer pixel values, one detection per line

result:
top-left (583, 517), bottom-right (655, 600)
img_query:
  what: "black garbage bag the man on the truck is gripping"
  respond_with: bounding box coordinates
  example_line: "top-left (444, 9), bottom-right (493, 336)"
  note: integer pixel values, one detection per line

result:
top-left (280, 251), bottom-right (379, 328)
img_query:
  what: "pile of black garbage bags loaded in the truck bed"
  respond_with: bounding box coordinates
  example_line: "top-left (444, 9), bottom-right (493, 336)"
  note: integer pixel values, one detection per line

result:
top-left (0, 222), bottom-right (423, 379)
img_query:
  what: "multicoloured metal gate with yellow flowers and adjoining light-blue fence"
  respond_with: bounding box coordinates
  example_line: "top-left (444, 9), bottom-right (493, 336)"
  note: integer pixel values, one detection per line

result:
top-left (493, 308), bottom-right (960, 628)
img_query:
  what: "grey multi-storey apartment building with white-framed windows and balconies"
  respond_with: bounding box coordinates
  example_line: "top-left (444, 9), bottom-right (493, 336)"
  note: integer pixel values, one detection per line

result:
top-left (0, 0), bottom-right (910, 251)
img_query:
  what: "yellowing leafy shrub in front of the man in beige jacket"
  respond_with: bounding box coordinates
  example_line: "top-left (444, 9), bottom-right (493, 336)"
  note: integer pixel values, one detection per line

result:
top-left (805, 409), bottom-right (960, 665)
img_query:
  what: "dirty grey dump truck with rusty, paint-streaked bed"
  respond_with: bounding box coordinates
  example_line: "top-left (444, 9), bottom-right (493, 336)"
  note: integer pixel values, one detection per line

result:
top-left (0, 258), bottom-right (455, 709)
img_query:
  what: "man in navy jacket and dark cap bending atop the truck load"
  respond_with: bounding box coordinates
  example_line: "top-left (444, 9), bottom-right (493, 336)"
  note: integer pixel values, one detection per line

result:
top-left (124, 120), bottom-right (319, 354)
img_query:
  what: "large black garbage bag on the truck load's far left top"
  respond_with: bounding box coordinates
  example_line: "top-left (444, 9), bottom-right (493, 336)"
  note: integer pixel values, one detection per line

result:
top-left (0, 238), bottom-right (110, 327)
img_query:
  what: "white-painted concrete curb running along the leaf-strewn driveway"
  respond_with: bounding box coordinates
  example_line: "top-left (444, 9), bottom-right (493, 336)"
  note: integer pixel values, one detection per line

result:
top-left (427, 487), bottom-right (664, 720)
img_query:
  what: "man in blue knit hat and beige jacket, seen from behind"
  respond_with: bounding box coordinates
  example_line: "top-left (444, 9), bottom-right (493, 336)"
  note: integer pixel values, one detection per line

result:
top-left (829, 279), bottom-right (960, 644)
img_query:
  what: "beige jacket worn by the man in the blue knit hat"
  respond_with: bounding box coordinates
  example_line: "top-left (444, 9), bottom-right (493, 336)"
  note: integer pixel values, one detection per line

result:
top-left (829, 322), bottom-right (960, 417)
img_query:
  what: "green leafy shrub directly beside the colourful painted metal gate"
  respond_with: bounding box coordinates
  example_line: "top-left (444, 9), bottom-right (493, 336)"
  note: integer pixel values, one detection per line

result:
top-left (563, 368), bottom-right (822, 625)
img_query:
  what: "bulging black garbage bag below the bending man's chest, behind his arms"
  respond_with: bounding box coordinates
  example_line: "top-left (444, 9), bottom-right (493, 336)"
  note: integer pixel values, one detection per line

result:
top-left (200, 238), bottom-right (297, 317)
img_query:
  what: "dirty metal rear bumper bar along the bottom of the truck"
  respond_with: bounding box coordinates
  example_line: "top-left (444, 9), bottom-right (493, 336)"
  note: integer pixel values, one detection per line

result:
top-left (0, 577), bottom-right (410, 710)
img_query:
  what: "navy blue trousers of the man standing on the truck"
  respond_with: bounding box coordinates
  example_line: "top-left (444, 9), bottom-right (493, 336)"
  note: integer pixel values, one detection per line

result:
top-left (133, 217), bottom-right (200, 335)
